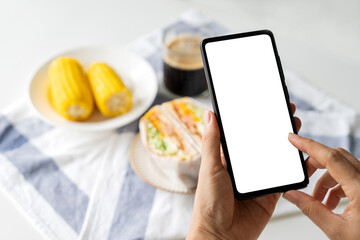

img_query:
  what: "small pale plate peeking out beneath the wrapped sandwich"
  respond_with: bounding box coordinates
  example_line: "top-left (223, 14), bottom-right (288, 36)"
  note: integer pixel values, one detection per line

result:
top-left (130, 133), bottom-right (196, 194)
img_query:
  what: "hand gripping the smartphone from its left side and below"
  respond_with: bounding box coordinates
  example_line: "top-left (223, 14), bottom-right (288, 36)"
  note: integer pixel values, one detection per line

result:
top-left (188, 104), bottom-right (301, 239)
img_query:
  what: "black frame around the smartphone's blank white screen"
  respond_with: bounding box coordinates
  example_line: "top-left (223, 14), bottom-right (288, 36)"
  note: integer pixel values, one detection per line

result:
top-left (200, 30), bottom-right (309, 200)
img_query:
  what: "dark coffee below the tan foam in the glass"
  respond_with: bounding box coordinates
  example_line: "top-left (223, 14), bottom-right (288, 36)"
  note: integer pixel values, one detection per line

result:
top-left (164, 62), bottom-right (207, 96)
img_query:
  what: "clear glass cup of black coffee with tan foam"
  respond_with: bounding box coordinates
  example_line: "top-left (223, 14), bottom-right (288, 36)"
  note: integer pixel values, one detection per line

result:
top-left (163, 27), bottom-right (211, 96)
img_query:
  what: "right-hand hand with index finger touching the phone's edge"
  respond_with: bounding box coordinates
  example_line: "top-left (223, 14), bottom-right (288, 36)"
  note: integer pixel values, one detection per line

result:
top-left (283, 134), bottom-right (360, 240)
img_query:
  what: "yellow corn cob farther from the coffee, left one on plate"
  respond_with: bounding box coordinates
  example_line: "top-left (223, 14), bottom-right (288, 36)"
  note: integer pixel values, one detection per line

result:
top-left (49, 57), bottom-right (94, 121)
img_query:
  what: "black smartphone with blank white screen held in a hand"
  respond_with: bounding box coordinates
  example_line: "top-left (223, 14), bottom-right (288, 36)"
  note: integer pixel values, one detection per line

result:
top-left (201, 30), bottom-right (309, 199)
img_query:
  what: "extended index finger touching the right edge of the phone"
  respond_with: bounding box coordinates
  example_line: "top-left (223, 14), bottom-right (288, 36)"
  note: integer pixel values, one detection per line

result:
top-left (289, 133), bottom-right (360, 197)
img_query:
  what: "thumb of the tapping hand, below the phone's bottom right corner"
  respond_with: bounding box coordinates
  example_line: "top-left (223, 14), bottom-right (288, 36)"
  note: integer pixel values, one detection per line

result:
top-left (283, 190), bottom-right (340, 232)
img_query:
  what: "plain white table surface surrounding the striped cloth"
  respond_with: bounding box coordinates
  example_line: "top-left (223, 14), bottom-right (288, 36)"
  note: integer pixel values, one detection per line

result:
top-left (0, 0), bottom-right (360, 240)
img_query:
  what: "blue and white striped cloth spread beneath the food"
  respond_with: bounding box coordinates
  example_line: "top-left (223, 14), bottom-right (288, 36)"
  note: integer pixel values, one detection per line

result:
top-left (0, 11), bottom-right (360, 240)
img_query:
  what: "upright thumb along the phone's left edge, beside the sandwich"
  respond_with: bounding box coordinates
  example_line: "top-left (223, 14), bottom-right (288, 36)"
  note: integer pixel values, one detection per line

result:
top-left (201, 111), bottom-right (223, 169)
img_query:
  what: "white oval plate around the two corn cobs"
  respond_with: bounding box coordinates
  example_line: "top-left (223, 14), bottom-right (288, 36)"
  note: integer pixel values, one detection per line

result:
top-left (28, 47), bottom-right (158, 131)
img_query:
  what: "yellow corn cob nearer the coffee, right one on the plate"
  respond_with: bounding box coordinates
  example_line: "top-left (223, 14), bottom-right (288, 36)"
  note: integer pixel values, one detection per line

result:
top-left (88, 63), bottom-right (132, 117)
